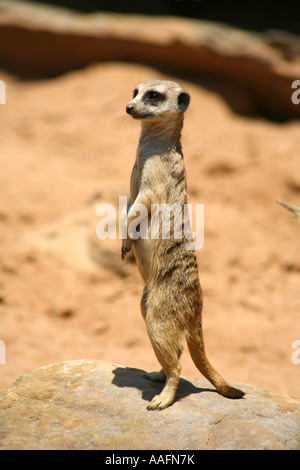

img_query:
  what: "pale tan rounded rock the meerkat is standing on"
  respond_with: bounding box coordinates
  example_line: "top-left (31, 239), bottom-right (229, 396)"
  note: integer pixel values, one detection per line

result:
top-left (0, 360), bottom-right (300, 450)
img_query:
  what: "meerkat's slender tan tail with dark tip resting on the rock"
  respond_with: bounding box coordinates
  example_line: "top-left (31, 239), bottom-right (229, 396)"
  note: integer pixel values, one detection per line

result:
top-left (186, 321), bottom-right (245, 398)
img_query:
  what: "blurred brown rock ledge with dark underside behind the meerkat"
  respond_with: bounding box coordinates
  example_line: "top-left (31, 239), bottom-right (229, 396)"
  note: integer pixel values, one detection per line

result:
top-left (0, 0), bottom-right (300, 120)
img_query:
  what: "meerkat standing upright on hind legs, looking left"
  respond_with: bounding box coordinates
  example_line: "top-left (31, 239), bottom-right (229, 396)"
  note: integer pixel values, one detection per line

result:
top-left (121, 80), bottom-right (244, 410)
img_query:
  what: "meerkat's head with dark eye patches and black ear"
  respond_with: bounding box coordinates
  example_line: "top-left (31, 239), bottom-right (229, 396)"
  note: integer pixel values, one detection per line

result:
top-left (126, 80), bottom-right (190, 121)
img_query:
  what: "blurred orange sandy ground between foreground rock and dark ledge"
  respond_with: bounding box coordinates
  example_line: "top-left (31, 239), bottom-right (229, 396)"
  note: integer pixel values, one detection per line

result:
top-left (0, 63), bottom-right (300, 396)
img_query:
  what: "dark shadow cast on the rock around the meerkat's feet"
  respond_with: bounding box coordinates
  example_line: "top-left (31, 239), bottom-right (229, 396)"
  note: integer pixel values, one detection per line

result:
top-left (112, 367), bottom-right (217, 402)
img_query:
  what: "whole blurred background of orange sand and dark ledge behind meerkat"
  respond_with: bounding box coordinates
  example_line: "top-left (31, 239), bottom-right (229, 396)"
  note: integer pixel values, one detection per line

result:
top-left (0, 0), bottom-right (300, 396)
